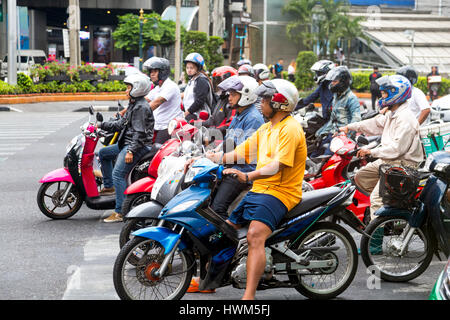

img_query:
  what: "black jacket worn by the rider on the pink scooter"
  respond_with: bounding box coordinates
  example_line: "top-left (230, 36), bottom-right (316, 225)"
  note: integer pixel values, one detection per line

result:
top-left (100, 97), bottom-right (155, 153)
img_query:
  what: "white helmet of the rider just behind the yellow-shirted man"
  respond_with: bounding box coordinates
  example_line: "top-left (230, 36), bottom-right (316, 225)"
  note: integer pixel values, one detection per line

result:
top-left (218, 76), bottom-right (258, 107)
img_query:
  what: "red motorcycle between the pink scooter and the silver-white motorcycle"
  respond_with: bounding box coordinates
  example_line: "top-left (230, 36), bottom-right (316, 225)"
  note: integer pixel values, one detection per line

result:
top-left (122, 118), bottom-right (198, 215)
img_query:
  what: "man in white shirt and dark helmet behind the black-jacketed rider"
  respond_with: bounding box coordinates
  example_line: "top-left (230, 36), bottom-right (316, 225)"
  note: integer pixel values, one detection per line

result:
top-left (144, 57), bottom-right (183, 144)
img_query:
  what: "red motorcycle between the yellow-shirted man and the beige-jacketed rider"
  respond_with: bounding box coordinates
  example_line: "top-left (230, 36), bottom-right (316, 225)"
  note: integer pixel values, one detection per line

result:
top-left (305, 134), bottom-right (379, 224)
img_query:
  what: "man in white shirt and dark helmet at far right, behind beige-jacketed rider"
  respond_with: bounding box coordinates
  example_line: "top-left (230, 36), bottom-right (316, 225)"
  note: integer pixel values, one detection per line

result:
top-left (397, 66), bottom-right (431, 125)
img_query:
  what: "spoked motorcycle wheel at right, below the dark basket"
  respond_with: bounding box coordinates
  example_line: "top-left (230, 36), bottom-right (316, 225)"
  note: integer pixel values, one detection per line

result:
top-left (360, 217), bottom-right (435, 282)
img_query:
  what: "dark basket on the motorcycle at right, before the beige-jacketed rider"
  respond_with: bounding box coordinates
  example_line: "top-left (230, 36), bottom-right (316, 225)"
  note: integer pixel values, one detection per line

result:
top-left (379, 164), bottom-right (420, 209)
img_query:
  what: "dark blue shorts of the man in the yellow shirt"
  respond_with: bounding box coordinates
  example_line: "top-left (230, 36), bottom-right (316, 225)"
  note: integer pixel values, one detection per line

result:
top-left (228, 191), bottom-right (288, 231)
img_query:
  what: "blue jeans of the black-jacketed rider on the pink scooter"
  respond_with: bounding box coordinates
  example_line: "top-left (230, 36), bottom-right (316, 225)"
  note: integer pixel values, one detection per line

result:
top-left (98, 143), bottom-right (151, 213)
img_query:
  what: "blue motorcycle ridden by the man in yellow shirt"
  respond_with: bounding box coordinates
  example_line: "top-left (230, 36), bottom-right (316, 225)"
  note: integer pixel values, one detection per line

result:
top-left (113, 158), bottom-right (363, 300)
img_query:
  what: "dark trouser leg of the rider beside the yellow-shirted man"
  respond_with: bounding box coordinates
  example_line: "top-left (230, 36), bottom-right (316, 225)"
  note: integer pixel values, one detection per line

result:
top-left (211, 176), bottom-right (248, 219)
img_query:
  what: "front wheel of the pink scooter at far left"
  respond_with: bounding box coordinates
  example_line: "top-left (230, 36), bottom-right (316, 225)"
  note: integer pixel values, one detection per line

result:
top-left (37, 181), bottom-right (83, 220)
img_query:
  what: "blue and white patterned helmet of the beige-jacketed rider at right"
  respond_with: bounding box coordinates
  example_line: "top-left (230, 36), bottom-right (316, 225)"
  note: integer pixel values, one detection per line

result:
top-left (375, 74), bottom-right (412, 108)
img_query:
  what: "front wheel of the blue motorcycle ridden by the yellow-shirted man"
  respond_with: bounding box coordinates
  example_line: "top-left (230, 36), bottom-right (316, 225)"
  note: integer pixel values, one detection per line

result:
top-left (113, 237), bottom-right (195, 300)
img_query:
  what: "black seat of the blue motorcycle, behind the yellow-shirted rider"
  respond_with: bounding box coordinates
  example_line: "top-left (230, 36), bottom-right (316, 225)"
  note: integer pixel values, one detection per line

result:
top-left (283, 187), bottom-right (342, 221)
